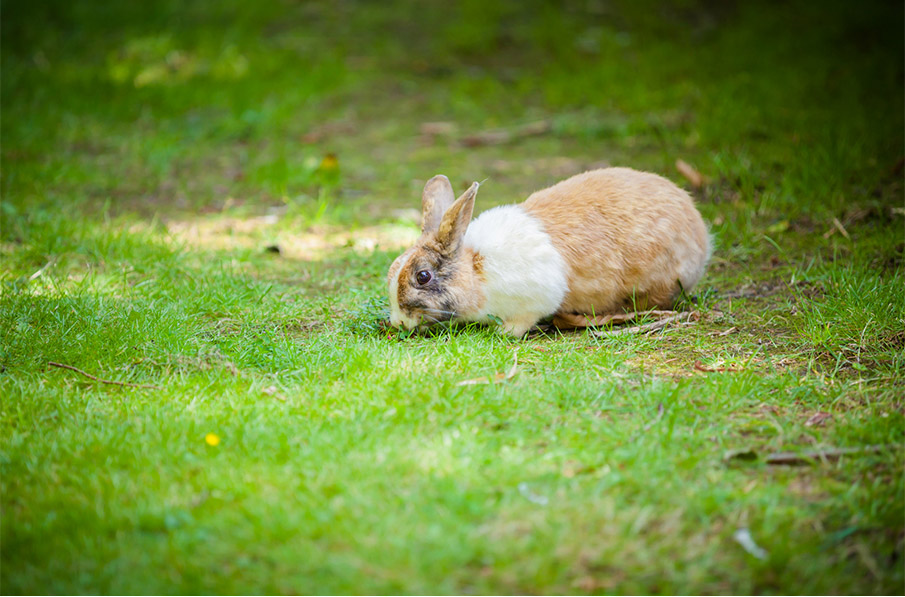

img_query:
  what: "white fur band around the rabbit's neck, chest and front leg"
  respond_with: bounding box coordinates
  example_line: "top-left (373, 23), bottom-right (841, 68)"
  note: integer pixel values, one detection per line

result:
top-left (464, 205), bottom-right (569, 336)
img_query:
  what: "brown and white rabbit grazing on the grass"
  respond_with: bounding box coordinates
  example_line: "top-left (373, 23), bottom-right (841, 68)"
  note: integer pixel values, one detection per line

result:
top-left (387, 168), bottom-right (711, 337)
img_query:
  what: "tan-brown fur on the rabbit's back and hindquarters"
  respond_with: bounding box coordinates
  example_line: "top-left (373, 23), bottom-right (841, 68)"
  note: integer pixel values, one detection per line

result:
top-left (522, 168), bottom-right (710, 315)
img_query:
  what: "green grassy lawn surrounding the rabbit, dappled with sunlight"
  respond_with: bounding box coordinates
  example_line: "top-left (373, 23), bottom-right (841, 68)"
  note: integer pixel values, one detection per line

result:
top-left (0, 0), bottom-right (905, 594)
